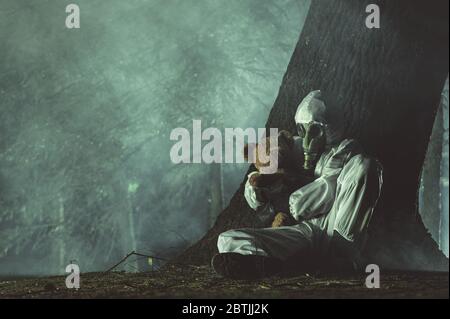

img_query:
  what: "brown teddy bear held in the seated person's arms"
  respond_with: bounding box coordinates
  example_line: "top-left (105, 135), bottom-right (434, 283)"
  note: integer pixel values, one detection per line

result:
top-left (244, 131), bottom-right (305, 227)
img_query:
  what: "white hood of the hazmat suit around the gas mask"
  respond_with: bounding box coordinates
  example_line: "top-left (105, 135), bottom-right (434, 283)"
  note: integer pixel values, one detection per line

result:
top-left (295, 90), bottom-right (343, 147)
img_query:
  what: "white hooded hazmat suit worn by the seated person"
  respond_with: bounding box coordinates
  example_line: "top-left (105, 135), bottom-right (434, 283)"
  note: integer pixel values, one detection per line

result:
top-left (218, 91), bottom-right (382, 261)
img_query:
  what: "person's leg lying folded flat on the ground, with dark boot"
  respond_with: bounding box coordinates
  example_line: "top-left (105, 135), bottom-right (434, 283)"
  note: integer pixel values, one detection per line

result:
top-left (212, 223), bottom-right (314, 279)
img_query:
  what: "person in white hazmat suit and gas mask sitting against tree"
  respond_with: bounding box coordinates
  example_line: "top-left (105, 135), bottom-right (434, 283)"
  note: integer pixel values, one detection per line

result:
top-left (212, 91), bottom-right (382, 279)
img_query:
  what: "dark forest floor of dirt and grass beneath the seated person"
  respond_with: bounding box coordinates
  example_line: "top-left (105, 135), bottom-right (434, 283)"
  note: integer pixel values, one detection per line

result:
top-left (0, 266), bottom-right (449, 299)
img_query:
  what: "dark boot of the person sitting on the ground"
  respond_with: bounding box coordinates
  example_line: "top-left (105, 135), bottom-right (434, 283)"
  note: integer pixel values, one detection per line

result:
top-left (211, 253), bottom-right (282, 279)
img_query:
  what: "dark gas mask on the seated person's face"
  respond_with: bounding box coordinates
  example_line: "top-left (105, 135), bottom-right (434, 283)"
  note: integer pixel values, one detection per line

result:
top-left (297, 121), bottom-right (326, 171)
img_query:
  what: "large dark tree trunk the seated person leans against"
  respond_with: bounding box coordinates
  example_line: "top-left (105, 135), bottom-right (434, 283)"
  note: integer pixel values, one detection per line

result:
top-left (177, 0), bottom-right (448, 269)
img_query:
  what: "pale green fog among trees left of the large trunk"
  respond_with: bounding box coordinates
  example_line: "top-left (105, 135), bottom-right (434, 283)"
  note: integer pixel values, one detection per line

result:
top-left (0, 0), bottom-right (309, 275)
